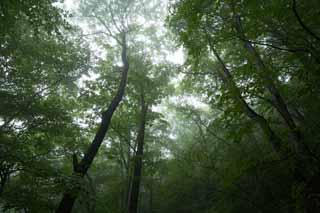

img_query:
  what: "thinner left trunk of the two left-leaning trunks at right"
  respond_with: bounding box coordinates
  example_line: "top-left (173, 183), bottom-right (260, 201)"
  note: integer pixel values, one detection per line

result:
top-left (207, 37), bottom-right (282, 153)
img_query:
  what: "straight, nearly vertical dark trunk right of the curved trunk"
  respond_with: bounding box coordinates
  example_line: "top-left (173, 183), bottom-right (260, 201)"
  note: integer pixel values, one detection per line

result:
top-left (128, 94), bottom-right (148, 213)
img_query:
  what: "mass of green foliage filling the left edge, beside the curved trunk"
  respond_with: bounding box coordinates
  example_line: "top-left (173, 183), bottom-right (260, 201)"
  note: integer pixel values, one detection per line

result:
top-left (0, 1), bottom-right (89, 212)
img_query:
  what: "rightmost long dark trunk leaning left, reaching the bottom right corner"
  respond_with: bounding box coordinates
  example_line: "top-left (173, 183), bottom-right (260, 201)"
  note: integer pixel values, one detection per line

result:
top-left (235, 15), bottom-right (320, 213)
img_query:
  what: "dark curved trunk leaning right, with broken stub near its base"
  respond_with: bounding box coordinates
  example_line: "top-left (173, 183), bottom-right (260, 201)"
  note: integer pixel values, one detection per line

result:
top-left (56, 34), bottom-right (129, 213)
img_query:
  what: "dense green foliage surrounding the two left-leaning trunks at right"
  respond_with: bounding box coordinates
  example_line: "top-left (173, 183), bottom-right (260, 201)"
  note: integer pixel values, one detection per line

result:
top-left (158, 0), bottom-right (320, 212)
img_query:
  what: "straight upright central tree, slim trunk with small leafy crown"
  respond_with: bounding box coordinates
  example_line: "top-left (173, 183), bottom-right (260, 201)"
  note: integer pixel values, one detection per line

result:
top-left (128, 52), bottom-right (170, 213)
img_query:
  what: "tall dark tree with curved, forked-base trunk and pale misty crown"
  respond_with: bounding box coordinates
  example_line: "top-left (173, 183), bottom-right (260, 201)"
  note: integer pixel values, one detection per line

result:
top-left (56, 0), bottom-right (166, 212)
